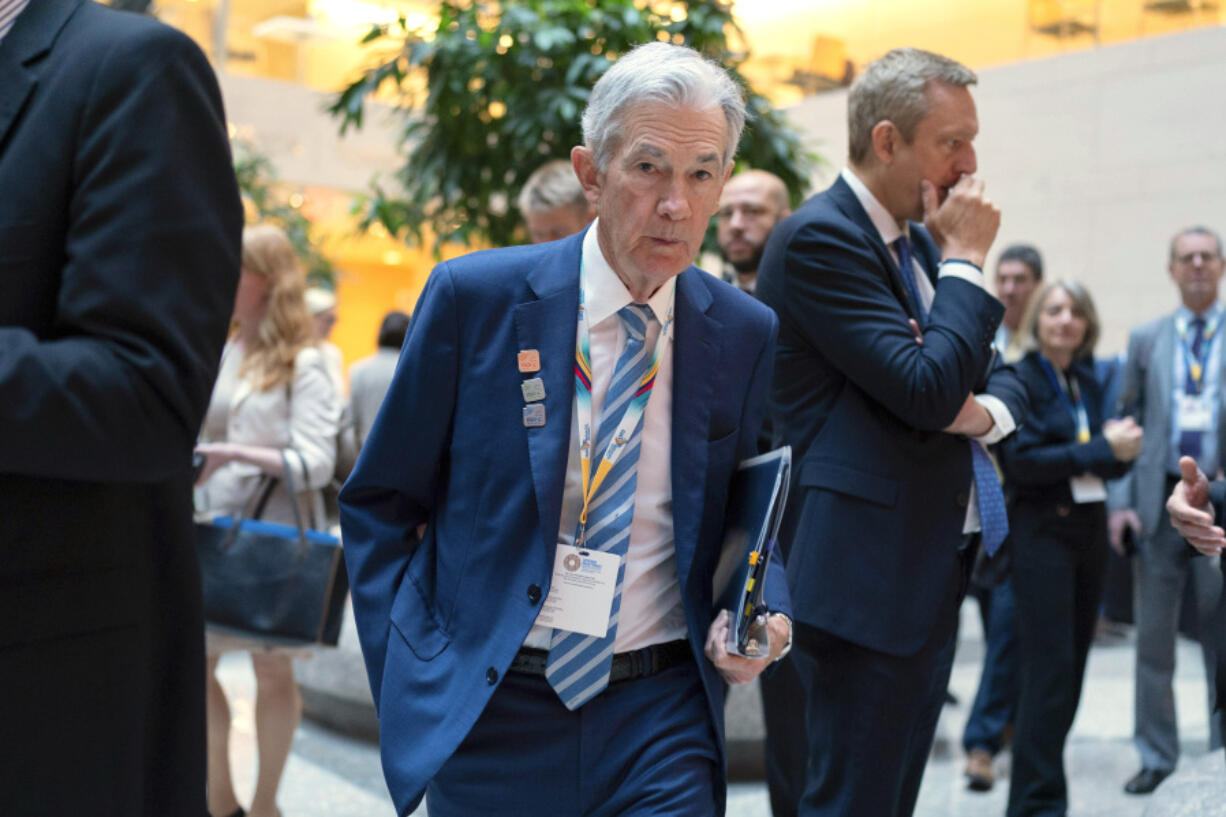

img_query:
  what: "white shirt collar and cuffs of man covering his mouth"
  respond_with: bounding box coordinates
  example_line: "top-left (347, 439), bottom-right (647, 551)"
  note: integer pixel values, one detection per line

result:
top-left (841, 167), bottom-right (1018, 534)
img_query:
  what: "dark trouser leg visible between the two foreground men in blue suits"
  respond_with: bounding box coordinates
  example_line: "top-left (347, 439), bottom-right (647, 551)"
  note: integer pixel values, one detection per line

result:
top-left (759, 658), bottom-right (809, 817)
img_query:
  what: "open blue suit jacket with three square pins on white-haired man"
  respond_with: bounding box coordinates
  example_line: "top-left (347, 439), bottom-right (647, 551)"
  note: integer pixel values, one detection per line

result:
top-left (341, 229), bottom-right (790, 813)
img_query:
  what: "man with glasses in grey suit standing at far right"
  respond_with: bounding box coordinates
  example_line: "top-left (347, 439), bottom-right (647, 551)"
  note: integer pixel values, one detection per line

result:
top-left (1110, 227), bottom-right (1226, 794)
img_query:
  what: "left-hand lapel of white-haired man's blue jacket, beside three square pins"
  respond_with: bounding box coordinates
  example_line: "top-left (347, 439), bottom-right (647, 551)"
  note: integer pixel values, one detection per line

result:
top-left (509, 233), bottom-right (582, 559)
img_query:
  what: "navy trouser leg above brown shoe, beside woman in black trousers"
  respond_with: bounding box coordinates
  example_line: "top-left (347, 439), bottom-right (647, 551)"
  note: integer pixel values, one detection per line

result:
top-left (962, 578), bottom-right (1020, 756)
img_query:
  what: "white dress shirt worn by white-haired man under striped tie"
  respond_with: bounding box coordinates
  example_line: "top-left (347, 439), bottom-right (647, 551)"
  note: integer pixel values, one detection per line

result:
top-left (524, 220), bottom-right (685, 653)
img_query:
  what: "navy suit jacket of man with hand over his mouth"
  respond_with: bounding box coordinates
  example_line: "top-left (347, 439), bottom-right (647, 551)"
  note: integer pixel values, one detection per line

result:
top-left (758, 179), bottom-right (1026, 655)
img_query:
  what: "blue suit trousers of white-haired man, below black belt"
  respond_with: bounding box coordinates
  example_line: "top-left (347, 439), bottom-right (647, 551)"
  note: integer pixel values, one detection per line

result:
top-left (425, 664), bottom-right (726, 817)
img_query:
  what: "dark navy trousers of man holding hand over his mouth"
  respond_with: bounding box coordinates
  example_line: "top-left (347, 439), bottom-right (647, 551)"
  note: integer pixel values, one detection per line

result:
top-left (792, 546), bottom-right (977, 817)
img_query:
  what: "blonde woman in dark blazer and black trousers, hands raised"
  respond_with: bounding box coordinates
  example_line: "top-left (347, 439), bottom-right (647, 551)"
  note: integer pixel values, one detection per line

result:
top-left (999, 281), bottom-right (1141, 817)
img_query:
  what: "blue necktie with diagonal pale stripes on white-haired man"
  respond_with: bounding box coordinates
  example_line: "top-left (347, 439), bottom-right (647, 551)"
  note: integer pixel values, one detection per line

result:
top-left (544, 303), bottom-right (658, 710)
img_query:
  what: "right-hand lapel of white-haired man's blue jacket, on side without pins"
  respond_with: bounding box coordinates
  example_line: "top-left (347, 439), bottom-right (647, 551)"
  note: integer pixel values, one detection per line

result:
top-left (672, 266), bottom-right (720, 595)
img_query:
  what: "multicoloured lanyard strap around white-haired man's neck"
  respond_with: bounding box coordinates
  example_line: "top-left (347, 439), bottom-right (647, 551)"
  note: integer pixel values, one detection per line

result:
top-left (575, 263), bottom-right (677, 539)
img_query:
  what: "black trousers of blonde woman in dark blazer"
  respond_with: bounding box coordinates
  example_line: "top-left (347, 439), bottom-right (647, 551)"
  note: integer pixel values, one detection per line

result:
top-left (1007, 503), bottom-right (1107, 817)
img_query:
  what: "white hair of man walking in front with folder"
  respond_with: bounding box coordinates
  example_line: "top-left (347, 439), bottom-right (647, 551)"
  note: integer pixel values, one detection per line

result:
top-left (582, 43), bottom-right (745, 172)
